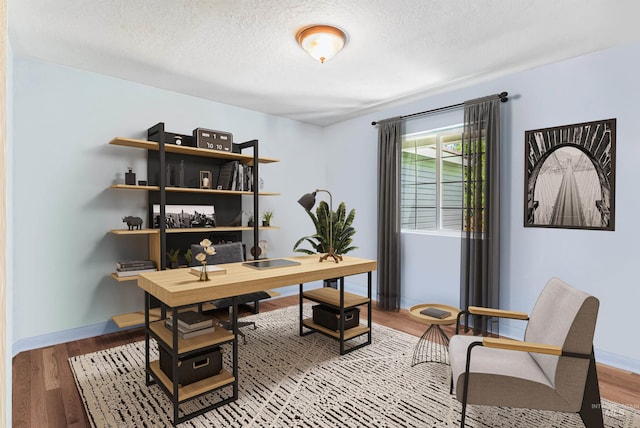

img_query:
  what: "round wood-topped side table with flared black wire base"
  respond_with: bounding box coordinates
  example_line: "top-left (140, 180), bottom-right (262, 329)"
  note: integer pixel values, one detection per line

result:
top-left (409, 303), bottom-right (460, 367)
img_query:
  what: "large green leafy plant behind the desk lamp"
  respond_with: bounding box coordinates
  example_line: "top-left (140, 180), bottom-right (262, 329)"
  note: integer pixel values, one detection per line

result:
top-left (293, 201), bottom-right (358, 255)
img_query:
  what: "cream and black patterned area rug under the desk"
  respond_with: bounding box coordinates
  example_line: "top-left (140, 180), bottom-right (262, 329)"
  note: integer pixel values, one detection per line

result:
top-left (69, 306), bottom-right (640, 428)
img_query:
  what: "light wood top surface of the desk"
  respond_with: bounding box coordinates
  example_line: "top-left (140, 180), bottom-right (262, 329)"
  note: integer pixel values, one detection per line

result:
top-left (138, 255), bottom-right (377, 307)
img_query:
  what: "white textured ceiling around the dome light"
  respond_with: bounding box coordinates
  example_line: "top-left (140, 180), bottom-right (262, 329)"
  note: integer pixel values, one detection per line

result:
top-left (8, 0), bottom-right (640, 125)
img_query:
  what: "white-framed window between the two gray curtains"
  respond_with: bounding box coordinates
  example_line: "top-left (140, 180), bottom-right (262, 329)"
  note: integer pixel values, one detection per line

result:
top-left (400, 125), bottom-right (463, 231)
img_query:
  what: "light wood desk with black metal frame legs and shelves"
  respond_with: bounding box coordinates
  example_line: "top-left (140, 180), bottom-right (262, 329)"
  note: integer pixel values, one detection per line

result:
top-left (138, 255), bottom-right (377, 425)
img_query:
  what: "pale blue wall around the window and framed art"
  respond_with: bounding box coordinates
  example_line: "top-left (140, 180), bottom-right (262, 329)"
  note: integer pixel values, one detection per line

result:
top-left (324, 44), bottom-right (640, 372)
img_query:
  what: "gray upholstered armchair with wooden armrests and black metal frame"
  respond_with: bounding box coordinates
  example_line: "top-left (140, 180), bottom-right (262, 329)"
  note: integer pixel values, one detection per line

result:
top-left (449, 278), bottom-right (604, 428)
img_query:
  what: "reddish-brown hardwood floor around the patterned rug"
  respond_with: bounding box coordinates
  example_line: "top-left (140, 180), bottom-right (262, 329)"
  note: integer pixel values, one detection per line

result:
top-left (12, 296), bottom-right (640, 428)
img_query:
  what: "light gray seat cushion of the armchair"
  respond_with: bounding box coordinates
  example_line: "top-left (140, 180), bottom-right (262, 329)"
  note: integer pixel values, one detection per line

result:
top-left (449, 335), bottom-right (576, 411)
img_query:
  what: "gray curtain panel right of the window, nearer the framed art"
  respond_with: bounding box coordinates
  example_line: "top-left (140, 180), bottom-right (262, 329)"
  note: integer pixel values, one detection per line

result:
top-left (460, 96), bottom-right (500, 334)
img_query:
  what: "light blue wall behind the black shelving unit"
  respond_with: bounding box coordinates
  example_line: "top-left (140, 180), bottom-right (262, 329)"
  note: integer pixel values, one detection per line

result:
top-left (9, 57), bottom-right (325, 355)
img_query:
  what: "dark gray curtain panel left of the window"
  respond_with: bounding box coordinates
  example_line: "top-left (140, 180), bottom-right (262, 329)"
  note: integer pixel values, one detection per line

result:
top-left (377, 117), bottom-right (403, 311)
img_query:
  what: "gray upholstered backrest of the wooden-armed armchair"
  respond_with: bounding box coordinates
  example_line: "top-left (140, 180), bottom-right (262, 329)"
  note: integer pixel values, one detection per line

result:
top-left (525, 278), bottom-right (600, 403)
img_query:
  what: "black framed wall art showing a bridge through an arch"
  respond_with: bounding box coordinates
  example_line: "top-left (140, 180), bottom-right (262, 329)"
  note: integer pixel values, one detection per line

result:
top-left (524, 119), bottom-right (616, 230)
